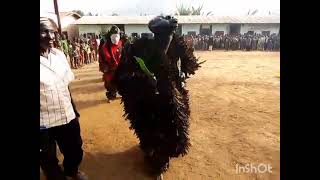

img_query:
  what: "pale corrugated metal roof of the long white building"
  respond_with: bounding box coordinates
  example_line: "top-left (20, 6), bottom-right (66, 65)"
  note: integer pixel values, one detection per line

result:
top-left (74, 16), bottom-right (280, 24)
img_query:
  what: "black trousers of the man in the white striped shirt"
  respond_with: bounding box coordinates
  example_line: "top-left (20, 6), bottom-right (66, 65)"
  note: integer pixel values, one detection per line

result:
top-left (40, 118), bottom-right (83, 180)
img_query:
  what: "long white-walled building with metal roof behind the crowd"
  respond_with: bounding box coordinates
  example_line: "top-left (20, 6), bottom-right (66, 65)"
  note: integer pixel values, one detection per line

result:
top-left (73, 15), bottom-right (280, 38)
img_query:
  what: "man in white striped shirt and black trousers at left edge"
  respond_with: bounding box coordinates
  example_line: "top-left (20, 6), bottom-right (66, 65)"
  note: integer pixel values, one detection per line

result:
top-left (40, 18), bottom-right (87, 180)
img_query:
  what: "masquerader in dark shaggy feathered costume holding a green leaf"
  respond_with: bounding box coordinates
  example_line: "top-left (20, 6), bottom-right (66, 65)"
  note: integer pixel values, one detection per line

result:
top-left (115, 16), bottom-right (201, 179)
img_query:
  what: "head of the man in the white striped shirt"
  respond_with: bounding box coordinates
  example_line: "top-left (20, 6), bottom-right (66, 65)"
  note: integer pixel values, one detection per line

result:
top-left (40, 17), bottom-right (58, 51)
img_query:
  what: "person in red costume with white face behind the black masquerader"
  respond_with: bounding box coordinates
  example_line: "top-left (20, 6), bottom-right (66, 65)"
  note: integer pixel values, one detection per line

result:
top-left (99, 25), bottom-right (123, 102)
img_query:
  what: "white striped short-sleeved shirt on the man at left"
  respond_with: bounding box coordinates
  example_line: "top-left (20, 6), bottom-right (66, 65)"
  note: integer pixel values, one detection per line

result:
top-left (40, 48), bottom-right (76, 129)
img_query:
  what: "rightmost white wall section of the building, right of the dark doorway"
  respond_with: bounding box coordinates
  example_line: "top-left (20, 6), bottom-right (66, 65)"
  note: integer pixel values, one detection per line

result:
top-left (240, 24), bottom-right (280, 34)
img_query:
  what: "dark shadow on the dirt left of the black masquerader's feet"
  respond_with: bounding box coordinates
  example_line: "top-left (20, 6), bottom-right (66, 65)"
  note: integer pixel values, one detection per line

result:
top-left (81, 146), bottom-right (155, 180)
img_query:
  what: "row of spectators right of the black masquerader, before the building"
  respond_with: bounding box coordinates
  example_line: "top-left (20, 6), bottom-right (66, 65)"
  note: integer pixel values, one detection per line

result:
top-left (184, 34), bottom-right (280, 51)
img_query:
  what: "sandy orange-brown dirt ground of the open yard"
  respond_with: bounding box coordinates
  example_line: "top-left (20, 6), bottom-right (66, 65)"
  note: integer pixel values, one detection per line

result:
top-left (41, 51), bottom-right (280, 180)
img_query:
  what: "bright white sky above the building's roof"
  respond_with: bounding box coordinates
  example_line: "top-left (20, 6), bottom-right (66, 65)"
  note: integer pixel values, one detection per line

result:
top-left (40, 0), bottom-right (280, 15)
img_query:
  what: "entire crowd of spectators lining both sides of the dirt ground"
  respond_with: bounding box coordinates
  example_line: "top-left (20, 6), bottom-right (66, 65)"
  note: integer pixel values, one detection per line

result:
top-left (50, 31), bottom-right (280, 69)
